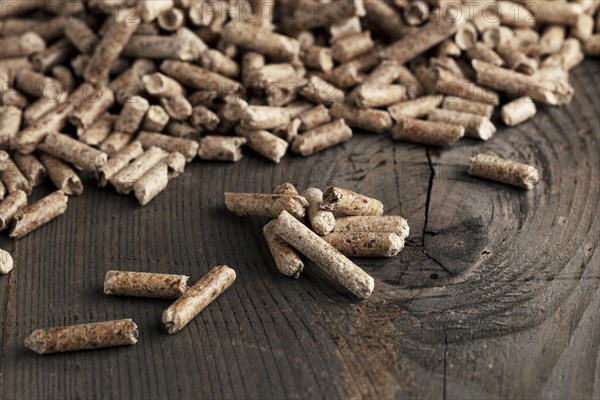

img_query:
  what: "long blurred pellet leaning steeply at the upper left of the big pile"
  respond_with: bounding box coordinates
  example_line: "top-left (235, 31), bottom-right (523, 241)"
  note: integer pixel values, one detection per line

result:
top-left (83, 7), bottom-right (141, 83)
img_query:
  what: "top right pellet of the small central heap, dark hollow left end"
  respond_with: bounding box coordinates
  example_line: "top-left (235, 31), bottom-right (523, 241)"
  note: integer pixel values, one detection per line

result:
top-left (321, 186), bottom-right (383, 215)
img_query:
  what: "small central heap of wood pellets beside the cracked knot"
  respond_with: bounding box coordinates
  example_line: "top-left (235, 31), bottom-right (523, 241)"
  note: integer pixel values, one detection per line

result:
top-left (225, 183), bottom-right (409, 299)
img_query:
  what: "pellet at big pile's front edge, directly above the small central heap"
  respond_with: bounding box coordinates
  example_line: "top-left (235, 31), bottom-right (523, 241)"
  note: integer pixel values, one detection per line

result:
top-left (291, 119), bottom-right (352, 156)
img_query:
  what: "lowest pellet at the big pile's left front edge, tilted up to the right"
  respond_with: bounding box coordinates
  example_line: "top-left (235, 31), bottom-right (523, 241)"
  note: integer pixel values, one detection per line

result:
top-left (10, 190), bottom-right (69, 239)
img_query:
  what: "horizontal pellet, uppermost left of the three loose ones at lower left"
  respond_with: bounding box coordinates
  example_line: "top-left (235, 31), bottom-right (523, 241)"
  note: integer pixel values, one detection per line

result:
top-left (104, 271), bottom-right (189, 299)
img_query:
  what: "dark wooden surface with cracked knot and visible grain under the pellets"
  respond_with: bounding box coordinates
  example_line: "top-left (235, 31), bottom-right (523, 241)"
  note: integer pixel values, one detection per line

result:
top-left (0, 61), bottom-right (600, 399)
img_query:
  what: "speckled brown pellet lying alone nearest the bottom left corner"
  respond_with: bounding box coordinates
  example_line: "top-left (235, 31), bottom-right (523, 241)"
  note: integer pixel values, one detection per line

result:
top-left (25, 319), bottom-right (138, 354)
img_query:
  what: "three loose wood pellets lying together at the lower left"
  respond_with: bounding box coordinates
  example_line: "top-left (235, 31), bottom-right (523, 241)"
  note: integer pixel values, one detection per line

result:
top-left (25, 265), bottom-right (236, 354)
